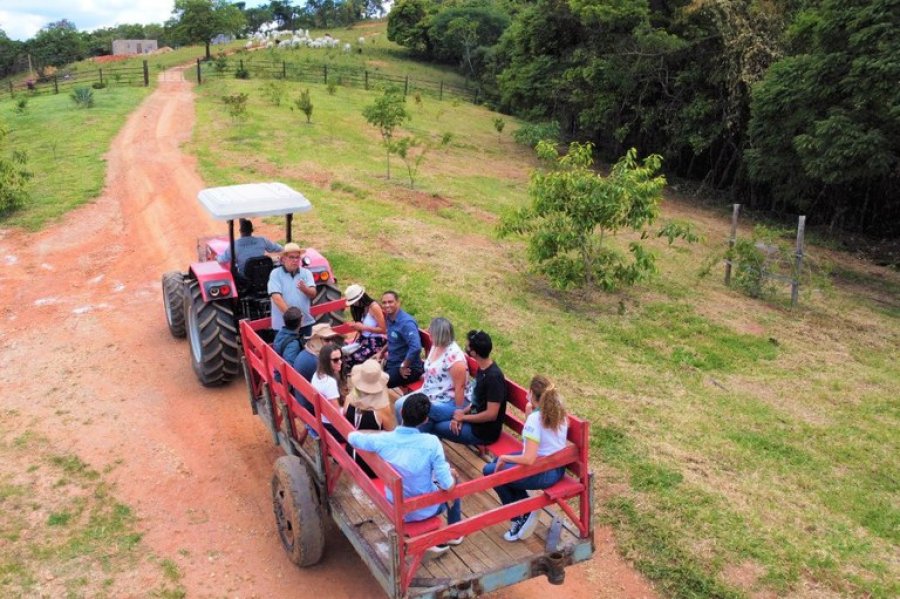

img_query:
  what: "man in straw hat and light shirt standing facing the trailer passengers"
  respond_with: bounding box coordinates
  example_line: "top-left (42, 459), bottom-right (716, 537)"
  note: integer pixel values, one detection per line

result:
top-left (268, 243), bottom-right (316, 340)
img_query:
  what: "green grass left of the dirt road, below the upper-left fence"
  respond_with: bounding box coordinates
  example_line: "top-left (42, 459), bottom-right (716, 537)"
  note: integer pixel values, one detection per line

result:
top-left (0, 87), bottom-right (150, 230)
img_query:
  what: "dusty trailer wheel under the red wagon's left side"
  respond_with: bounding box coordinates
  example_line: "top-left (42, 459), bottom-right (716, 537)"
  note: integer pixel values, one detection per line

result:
top-left (272, 456), bottom-right (325, 568)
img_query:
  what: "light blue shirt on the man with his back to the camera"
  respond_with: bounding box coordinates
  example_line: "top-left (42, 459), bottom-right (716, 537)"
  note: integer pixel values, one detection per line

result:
top-left (347, 426), bottom-right (454, 522)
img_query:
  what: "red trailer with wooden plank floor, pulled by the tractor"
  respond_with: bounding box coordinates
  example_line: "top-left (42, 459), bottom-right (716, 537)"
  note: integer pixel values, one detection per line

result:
top-left (240, 300), bottom-right (594, 599)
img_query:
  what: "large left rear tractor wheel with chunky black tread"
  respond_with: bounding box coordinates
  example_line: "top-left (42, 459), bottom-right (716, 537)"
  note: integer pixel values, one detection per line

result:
top-left (185, 280), bottom-right (241, 387)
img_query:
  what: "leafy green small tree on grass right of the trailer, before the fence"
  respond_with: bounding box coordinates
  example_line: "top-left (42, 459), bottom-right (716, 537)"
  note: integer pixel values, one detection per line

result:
top-left (499, 142), bottom-right (679, 290)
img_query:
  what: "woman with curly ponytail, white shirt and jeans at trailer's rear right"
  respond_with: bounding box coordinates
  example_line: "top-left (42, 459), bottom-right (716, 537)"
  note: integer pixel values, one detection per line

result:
top-left (483, 375), bottom-right (569, 541)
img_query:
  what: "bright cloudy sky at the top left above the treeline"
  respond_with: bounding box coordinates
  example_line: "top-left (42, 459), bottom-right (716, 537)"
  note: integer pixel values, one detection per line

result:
top-left (0, 0), bottom-right (256, 41)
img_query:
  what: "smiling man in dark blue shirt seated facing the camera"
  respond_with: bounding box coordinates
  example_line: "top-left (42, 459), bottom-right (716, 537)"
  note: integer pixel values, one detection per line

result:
top-left (381, 291), bottom-right (425, 388)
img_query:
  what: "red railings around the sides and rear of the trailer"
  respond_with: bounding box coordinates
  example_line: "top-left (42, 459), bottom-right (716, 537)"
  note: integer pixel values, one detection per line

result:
top-left (240, 316), bottom-right (593, 594)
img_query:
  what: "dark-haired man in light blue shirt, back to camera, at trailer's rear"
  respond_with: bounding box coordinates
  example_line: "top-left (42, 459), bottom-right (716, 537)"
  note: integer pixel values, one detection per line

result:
top-left (347, 393), bottom-right (463, 554)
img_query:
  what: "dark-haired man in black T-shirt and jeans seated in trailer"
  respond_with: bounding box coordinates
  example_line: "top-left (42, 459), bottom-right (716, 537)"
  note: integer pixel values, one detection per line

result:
top-left (431, 331), bottom-right (506, 445)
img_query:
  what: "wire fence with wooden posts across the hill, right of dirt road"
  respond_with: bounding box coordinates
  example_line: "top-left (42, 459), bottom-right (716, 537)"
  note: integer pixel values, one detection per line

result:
top-left (197, 59), bottom-right (483, 104)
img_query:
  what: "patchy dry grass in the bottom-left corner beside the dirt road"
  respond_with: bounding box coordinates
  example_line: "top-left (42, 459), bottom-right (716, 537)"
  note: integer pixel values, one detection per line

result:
top-left (0, 412), bottom-right (171, 597)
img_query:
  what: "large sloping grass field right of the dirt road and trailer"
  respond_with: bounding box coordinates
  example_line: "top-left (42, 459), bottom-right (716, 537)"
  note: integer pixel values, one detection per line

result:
top-left (189, 72), bottom-right (900, 597)
